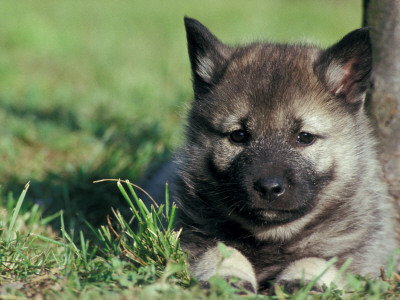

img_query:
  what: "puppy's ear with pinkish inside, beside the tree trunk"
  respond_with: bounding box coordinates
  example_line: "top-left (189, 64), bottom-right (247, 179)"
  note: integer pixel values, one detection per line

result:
top-left (314, 28), bottom-right (372, 107)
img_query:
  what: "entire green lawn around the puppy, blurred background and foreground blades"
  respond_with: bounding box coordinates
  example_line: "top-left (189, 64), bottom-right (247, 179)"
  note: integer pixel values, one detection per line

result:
top-left (0, 0), bottom-right (399, 299)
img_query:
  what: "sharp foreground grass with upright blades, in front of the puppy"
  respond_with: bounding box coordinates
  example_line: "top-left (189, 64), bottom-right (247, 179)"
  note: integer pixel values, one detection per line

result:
top-left (0, 180), bottom-right (400, 299)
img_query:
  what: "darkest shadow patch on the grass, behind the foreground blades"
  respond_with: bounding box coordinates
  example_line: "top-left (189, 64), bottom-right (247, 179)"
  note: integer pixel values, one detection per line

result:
top-left (4, 155), bottom-right (172, 237)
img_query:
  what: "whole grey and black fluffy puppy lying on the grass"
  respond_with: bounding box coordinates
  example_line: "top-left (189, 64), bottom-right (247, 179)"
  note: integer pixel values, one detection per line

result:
top-left (143, 18), bottom-right (397, 292)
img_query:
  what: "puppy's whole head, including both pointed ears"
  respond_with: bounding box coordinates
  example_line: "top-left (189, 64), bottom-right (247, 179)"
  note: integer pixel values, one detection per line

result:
top-left (187, 17), bottom-right (370, 224)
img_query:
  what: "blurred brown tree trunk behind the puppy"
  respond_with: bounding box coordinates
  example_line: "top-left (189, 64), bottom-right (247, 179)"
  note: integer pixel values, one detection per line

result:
top-left (363, 0), bottom-right (400, 201)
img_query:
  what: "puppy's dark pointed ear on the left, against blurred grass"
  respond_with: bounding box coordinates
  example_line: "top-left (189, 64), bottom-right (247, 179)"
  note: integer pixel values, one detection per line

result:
top-left (185, 17), bottom-right (233, 95)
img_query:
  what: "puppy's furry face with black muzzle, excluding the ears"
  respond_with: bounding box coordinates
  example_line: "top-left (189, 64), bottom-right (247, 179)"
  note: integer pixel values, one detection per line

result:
top-left (189, 45), bottom-right (343, 224)
